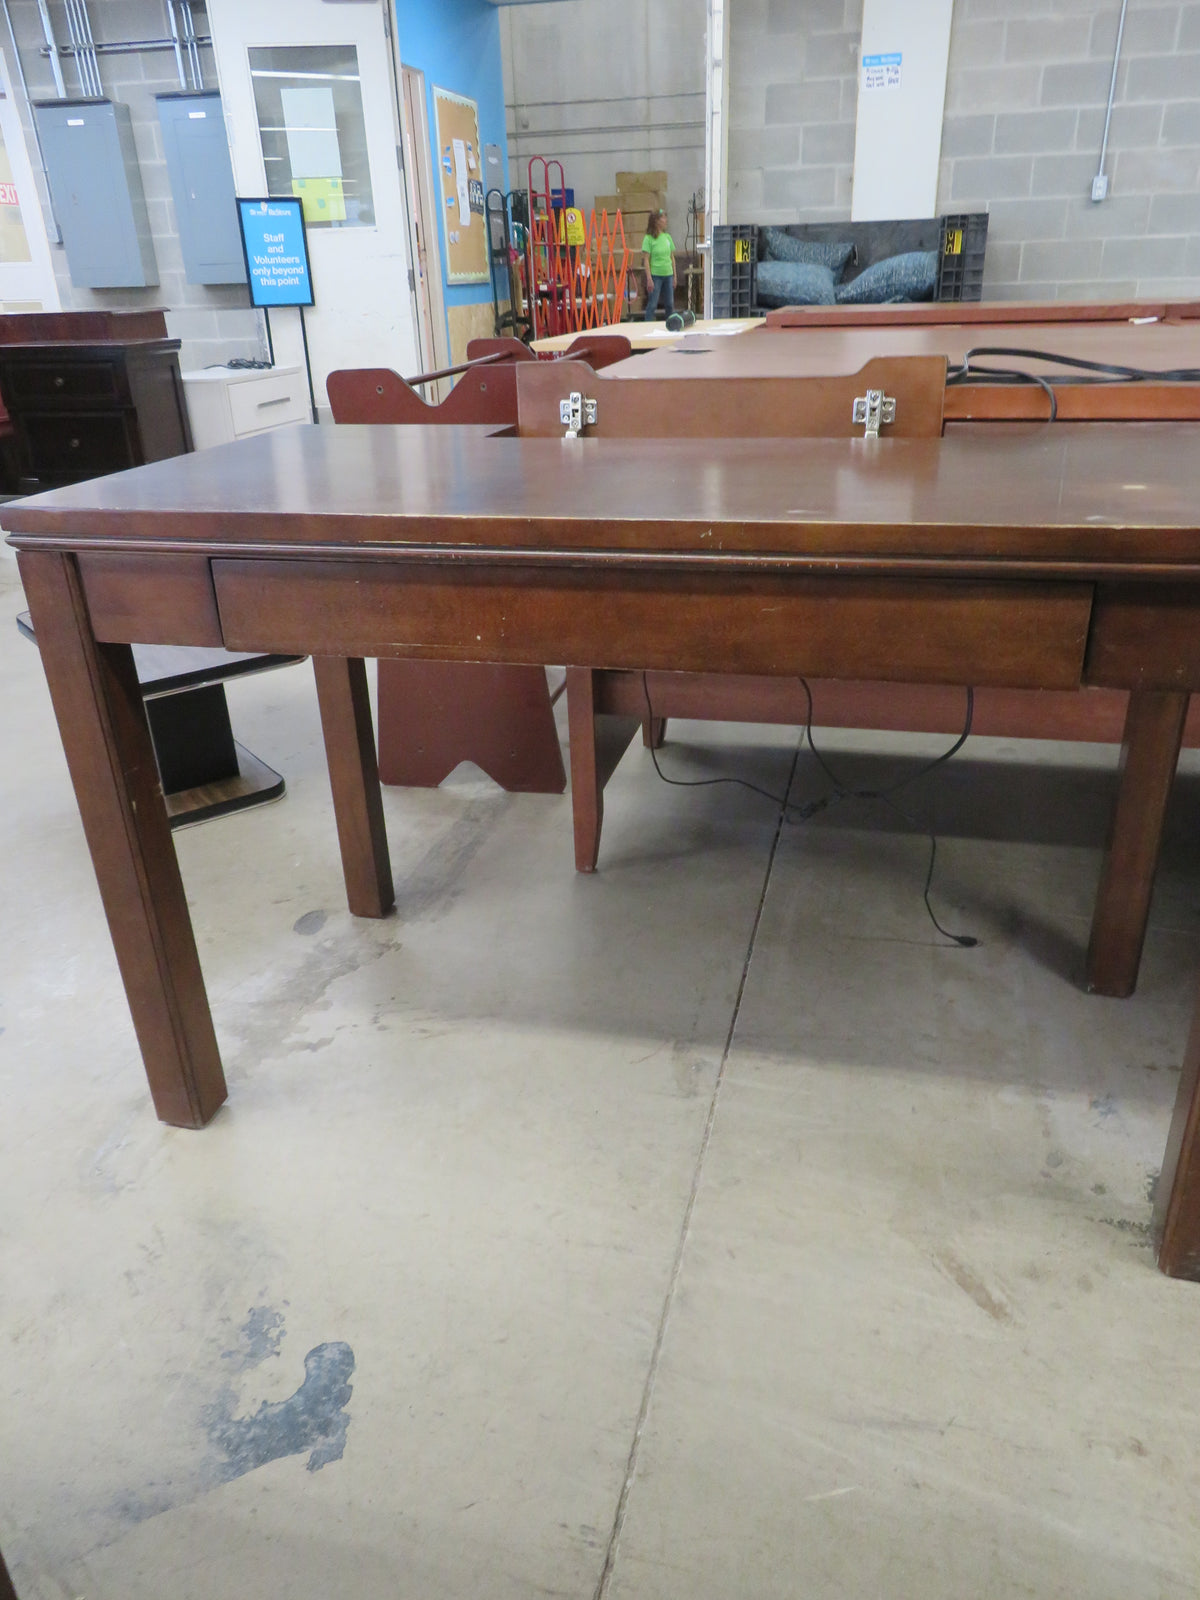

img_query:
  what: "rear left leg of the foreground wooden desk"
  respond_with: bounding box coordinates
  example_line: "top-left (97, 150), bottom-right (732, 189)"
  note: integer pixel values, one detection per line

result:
top-left (312, 656), bottom-right (395, 917)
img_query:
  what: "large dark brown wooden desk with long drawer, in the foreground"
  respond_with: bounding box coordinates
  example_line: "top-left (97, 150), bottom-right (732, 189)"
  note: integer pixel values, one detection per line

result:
top-left (3, 424), bottom-right (1200, 1277)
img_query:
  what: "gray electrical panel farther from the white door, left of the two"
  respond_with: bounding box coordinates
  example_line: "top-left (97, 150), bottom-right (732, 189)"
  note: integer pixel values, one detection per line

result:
top-left (34, 99), bottom-right (158, 290)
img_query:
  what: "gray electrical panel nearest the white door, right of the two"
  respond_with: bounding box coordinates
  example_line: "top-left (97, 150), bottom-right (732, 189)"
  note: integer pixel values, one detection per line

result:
top-left (155, 90), bottom-right (246, 283)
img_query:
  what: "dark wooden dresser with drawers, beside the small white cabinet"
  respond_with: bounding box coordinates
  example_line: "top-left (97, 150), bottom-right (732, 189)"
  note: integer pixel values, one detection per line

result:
top-left (0, 310), bottom-right (192, 494)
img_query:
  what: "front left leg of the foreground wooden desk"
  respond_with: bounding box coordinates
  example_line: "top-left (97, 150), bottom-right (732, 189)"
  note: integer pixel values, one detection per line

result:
top-left (19, 552), bottom-right (226, 1128)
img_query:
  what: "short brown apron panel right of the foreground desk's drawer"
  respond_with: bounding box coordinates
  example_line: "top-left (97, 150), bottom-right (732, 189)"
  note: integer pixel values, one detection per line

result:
top-left (1085, 584), bottom-right (1200, 690)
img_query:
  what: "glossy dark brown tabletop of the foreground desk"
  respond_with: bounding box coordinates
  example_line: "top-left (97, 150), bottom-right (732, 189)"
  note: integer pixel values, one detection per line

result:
top-left (0, 422), bottom-right (1200, 576)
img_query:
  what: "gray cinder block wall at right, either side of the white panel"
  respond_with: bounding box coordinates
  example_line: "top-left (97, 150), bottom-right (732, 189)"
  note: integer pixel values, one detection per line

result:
top-left (730, 0), bottom-right (1200, 299)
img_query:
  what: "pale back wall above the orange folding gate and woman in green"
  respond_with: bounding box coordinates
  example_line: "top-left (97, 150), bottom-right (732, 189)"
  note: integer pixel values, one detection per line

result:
top-left (501, 0), bottom-right (710, 248)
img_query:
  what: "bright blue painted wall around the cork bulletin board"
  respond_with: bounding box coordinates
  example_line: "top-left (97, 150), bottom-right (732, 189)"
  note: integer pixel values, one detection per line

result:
top-left (395, 0), bottom-right (509, 321)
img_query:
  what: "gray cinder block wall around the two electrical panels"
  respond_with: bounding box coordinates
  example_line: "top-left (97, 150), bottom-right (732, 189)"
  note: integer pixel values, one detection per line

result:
top-left (0, 0), bottom-right (259, 370)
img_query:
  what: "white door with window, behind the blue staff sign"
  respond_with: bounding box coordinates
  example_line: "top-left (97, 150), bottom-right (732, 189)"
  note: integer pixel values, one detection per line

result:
top-left (208, 0), bottom-right (419, 406)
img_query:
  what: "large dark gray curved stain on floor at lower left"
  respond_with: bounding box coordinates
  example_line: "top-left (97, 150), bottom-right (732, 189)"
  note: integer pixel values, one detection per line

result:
top-left (205, 1339), bottom-right (354, 1483)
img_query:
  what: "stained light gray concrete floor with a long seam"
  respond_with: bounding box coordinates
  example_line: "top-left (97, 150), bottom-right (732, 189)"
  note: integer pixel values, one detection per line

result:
top-left (0, 555), bottom-right (1200, 1600)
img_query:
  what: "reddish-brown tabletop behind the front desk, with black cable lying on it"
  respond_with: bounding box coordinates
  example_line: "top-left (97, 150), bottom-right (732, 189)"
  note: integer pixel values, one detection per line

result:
top-left (620, 322), bottom-right (1200, 379)
